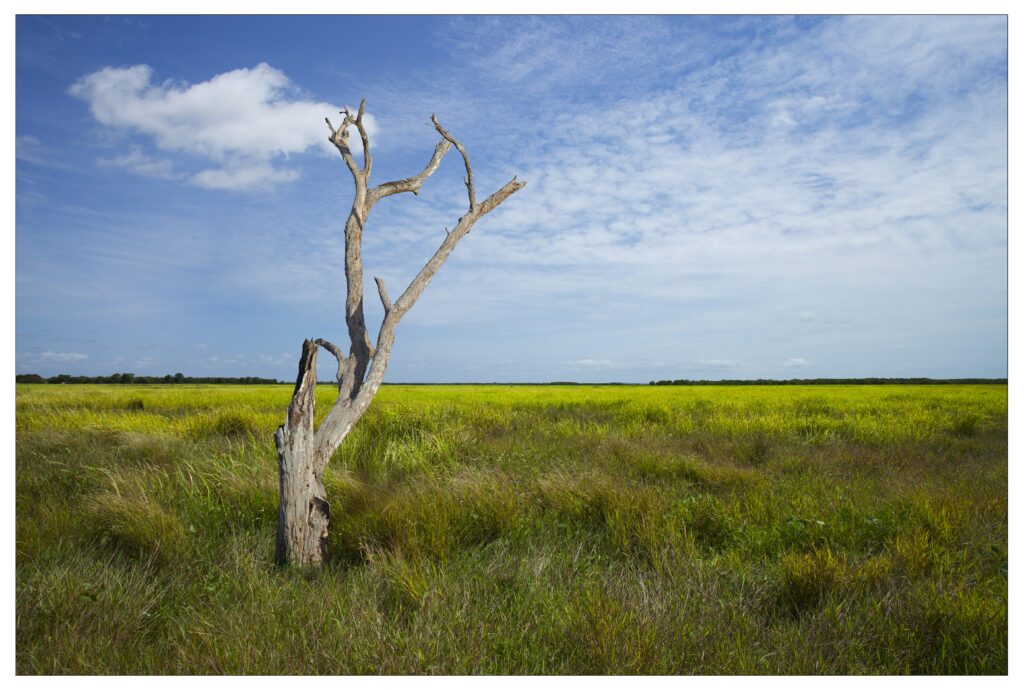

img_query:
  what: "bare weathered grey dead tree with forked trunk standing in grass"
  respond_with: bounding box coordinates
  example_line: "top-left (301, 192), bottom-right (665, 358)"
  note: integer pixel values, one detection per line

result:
top-left (274, 100), bottom-right (525, 566)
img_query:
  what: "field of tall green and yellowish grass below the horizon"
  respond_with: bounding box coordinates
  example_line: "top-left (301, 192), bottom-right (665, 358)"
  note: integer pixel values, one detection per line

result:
top-left (16, 385), bottom-right (1008, 674)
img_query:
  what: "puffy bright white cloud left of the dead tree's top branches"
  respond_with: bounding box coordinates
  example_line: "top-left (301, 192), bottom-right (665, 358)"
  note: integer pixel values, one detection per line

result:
top-left (70, 62), bottom-right (376, 189)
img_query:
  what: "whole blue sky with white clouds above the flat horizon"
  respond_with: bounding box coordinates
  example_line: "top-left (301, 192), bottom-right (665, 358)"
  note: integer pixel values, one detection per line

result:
top-left (15, 15), bottom-right (1008, 382)
